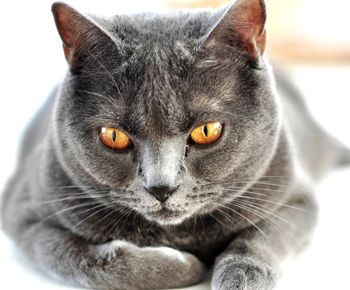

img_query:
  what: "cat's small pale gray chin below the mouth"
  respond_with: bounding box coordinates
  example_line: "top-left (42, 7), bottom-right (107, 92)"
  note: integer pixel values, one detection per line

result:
top-left (145, 208), bottom-right (191, 225)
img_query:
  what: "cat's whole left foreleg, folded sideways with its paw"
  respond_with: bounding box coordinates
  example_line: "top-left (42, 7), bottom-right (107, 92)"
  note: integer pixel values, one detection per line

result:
top-left (17, 222), bottom-right (205, 290)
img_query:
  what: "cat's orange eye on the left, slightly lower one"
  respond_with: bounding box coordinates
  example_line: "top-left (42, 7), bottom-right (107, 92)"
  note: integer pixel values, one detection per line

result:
top-left (100, 127), bottom-right (131, 150)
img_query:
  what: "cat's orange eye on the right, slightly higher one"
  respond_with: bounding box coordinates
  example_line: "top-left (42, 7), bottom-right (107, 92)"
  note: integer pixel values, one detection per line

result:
top-left (191, 122), bottom-right (222, 145)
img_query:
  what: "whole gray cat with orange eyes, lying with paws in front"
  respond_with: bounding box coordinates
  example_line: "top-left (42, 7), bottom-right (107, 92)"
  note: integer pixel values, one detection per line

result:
top-left (1, 0), bottom-right (350, 290)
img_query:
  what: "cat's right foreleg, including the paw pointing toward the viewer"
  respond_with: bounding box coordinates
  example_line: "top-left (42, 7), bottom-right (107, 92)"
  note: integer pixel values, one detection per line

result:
top-left (212, 191), bottom-right (317, 290)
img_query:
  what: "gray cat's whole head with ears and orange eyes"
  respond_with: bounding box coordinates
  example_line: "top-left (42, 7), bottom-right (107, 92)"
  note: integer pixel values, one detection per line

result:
top-left (53, 0), bottom-right (280, 224)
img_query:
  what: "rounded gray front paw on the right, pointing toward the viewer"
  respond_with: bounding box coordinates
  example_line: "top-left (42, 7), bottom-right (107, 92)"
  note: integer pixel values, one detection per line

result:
top-left (212, 256), bottom-right (277, 290)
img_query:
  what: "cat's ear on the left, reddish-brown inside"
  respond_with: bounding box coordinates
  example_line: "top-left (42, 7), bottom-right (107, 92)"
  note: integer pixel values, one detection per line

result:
top-left (52, 2), bottom-right (105, 66)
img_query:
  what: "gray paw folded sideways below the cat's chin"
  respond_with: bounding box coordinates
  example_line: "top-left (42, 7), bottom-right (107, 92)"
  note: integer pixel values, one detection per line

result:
top-left (93, 241), bottom-right (206, 289)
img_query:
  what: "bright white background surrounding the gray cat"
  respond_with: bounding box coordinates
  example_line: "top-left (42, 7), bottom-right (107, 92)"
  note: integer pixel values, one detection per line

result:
top-left (0, 0), bottom-right (350, 290)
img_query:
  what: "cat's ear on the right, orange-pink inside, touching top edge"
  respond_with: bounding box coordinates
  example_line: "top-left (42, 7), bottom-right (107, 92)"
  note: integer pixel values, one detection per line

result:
top-left (204, 0), bottom-right (266, 59)
